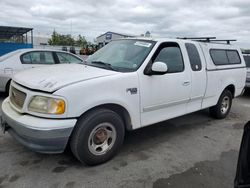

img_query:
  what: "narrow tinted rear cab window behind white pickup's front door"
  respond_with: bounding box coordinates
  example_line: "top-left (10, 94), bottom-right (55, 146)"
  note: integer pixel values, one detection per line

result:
top-left (185, 43), bottom-right (202, 71)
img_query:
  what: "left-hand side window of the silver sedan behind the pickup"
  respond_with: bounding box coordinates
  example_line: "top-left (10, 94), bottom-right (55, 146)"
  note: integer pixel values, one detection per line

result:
top-left (22, 52), bottom-right (55, 64)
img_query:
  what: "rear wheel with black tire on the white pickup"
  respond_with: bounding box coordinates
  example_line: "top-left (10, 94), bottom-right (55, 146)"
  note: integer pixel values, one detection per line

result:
top-left (209, 90), bottom-right (233, 119)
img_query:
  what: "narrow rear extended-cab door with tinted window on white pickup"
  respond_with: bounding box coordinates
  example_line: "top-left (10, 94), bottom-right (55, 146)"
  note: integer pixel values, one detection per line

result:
top-left (185, 42), bottom-right (207, 112)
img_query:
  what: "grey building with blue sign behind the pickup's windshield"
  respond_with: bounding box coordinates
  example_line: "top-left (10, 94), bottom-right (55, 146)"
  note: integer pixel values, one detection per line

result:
top-left (96, 31), bottom-right (135, 47)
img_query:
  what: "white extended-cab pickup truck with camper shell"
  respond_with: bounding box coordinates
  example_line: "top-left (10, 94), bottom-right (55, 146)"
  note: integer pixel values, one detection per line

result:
top-left (1, 38), bottom-right (246, 165)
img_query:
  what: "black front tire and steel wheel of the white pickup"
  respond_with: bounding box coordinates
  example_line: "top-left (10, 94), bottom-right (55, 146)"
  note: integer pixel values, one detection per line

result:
top-left (70, 109), bottom-right (125, 165)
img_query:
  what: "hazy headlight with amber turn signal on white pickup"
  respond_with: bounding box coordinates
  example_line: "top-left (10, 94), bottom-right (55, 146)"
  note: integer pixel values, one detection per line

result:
top-left (28, 96), bottom-right (65, 115)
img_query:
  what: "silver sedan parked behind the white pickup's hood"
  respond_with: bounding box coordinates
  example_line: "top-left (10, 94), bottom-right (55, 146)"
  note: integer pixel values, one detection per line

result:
top-left (0, 49), bottom-right (83, 93)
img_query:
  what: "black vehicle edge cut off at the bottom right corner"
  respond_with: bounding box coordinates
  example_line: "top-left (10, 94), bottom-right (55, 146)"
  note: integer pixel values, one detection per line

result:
top-left (234, 121), bottom-right (250, 188)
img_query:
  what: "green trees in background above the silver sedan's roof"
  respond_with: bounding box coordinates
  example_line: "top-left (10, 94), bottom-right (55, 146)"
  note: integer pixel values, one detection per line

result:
top-left (48, 30), bottom-right (87, 47)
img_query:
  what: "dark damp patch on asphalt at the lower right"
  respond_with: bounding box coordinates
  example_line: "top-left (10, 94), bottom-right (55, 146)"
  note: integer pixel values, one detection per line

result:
top-left (153, 150), bottom-right (238, 188)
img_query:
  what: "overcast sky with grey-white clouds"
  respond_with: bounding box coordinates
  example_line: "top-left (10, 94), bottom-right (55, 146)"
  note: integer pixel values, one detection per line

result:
top-left (0, 0), bottom-right (250, 48)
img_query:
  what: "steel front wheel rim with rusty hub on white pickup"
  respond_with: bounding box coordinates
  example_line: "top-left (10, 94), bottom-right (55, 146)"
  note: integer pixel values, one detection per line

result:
top-left (88, 123), bottom-right (117, 155)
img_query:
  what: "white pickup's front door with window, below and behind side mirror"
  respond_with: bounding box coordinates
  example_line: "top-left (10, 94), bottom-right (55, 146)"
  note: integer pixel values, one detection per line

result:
top-left (139, 42), bottom-right (191, 126)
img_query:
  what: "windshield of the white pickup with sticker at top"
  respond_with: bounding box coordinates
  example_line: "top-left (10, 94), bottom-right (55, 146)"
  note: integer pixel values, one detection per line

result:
top-left (86, 39), bottom-right (155, 72)
